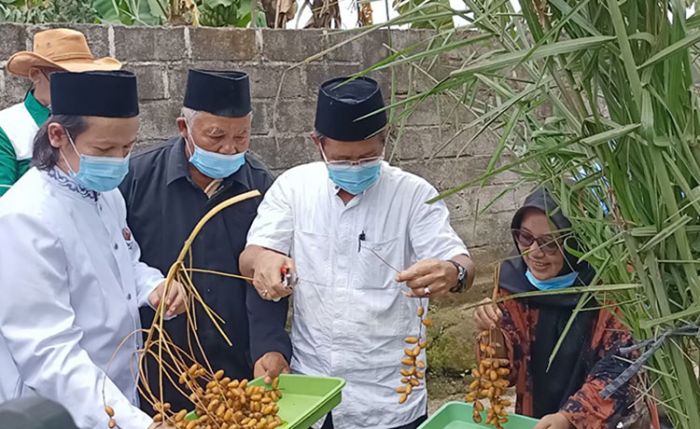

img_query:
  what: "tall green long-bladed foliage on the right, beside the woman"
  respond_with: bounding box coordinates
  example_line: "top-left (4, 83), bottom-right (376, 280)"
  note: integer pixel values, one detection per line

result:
top-left (371, 0), bottom-right (700, 429)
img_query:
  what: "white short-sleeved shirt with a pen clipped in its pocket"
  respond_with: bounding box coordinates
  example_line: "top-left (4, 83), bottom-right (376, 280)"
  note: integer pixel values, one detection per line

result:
top-left (248, 162), bottom-right (467, 429)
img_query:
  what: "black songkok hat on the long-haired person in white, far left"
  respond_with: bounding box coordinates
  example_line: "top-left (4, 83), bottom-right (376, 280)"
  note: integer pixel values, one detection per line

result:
top-left (50, 70), bottom-right (139, 118)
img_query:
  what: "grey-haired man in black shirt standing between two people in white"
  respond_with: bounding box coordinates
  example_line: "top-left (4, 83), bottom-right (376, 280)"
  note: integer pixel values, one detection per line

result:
top-left (120, 70), bottom-right (291, 410)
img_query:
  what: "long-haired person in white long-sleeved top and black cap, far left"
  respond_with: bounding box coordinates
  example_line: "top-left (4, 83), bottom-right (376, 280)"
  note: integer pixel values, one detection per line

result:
top-left (0, 71), bottom-right (185, 429)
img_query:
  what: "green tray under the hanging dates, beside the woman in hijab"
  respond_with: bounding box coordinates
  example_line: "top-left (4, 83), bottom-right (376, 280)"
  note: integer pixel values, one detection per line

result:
top-left (418, 402), bottom-right (537, 429)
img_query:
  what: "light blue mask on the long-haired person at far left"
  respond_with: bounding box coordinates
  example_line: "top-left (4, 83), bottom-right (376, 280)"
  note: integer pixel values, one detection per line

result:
top-left (61, 130), bottom-right (131, 192)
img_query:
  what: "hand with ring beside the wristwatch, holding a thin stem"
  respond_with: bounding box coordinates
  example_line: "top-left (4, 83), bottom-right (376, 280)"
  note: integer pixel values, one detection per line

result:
top-left (396, 259), bottom-right (459, 298)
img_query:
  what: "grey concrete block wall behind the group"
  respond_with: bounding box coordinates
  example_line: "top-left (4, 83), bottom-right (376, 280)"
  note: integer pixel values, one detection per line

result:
top-left (0, 24), bottom-right (523, 279)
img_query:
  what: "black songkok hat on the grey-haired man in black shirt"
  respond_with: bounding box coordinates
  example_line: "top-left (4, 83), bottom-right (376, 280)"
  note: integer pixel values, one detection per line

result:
top-left (184, 69), bottom-right (252, 118)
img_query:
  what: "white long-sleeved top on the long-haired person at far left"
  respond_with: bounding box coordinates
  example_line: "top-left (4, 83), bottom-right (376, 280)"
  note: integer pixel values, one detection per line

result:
top-left (0, 168), bottom-right (163, 429)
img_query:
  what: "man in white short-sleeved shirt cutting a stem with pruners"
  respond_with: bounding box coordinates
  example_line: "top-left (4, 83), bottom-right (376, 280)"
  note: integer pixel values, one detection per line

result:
top-left (240, 78), bottom-right (474, 429)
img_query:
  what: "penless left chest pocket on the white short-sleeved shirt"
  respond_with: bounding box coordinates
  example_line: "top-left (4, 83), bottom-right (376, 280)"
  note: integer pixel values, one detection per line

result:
top-left (292, 230), bottom-right (331, 286)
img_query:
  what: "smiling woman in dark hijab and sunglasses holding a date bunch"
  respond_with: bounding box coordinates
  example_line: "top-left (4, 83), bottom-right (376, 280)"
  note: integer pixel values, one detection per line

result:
top-left (475, 189), bottom-right (658, 429)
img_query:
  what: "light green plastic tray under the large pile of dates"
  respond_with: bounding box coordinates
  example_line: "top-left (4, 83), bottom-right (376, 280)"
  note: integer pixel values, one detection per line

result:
top-left (187, 374), bottom-right (345, 429)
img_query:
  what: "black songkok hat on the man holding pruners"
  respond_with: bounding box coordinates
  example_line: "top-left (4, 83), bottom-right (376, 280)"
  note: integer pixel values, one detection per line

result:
top-left (315, 77), bottom-right (387, 141)
